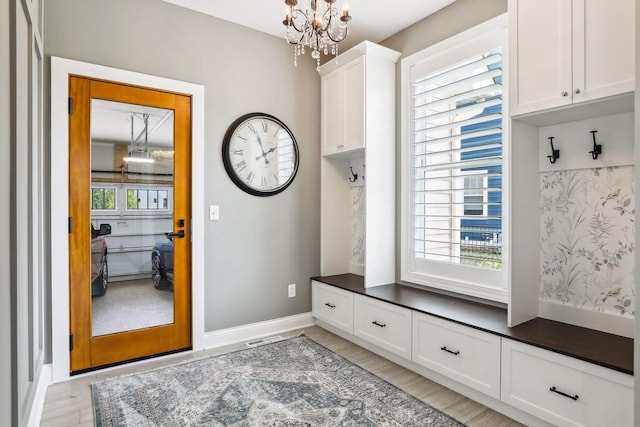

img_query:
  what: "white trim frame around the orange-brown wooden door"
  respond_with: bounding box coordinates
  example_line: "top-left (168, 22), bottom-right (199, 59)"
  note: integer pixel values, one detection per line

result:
top-left (51, 57), bottom-right (205, 382)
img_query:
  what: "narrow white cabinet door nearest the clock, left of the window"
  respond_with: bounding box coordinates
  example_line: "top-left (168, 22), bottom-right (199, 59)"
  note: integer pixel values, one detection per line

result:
top-left (321, 68), bottom-right (345, 156)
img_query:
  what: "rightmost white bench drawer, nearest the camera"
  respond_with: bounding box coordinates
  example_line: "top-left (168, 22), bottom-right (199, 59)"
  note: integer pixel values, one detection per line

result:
top-left (502, 338), bottom-right (633, 427)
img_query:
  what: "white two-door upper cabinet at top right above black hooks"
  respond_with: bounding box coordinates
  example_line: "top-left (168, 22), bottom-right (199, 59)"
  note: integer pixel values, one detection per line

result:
top-left (509, 0), bottom-right (635, 116)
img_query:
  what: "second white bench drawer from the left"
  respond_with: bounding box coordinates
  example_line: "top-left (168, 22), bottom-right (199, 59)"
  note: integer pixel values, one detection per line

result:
top-left (353, 295), bottom-right (411, 359)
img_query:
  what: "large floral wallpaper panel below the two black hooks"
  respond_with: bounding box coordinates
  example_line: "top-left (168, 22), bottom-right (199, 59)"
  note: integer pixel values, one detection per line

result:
top-left (540, 166), bottom-right (635, 316)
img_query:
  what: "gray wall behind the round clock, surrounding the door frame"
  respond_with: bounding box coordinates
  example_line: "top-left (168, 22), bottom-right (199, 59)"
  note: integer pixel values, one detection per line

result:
top-left (45, 0), bottom-right (320, 331)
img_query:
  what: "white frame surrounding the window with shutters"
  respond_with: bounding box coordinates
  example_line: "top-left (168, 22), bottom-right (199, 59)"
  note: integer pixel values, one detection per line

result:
top-left (400, 14), bottom-right (511, 303)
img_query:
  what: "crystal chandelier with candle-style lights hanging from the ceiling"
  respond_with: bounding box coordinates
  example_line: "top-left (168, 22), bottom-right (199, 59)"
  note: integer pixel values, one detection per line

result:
top-left (282, 0), bottom-right (351, 71)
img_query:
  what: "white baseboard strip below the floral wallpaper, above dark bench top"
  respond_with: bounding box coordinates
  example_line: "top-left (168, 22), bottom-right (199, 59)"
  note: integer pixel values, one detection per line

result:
top-left (538, 300), bottom-right (635, 338)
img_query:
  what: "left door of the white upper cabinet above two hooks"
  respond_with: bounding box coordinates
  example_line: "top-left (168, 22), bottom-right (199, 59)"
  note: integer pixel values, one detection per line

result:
top-left (509, 0), bottom-right (572, 115)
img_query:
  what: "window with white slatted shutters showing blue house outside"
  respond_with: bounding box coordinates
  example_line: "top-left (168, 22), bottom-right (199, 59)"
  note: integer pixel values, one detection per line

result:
top-left (412, 48), bottom-right (502, 269)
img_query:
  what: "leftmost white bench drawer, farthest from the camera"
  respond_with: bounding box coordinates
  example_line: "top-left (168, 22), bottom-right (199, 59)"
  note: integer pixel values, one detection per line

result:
top-left (311, 281), bottom-right (353, 334)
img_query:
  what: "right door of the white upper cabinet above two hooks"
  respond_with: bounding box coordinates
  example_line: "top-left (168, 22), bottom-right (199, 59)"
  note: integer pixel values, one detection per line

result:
top-left (573, 0), bottom-right (635, 103)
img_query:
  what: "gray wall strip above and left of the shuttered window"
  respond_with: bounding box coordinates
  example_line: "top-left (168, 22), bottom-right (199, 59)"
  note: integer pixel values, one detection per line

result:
top-left (380, 0), bottom-right (507, 290)
